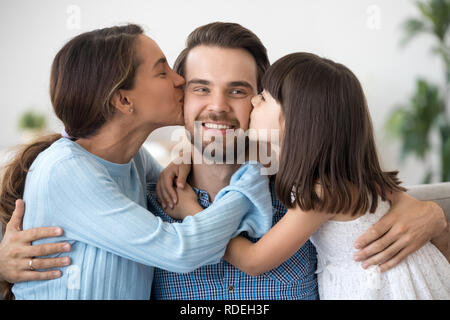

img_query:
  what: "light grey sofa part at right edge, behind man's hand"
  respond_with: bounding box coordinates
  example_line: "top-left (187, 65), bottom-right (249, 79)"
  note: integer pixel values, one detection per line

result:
top-left (406, 182), bottom-right (450, 221)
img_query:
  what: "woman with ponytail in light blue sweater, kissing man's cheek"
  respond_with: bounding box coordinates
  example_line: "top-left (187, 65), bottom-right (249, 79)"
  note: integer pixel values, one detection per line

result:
top-left (1, 25), bottom-right (271, 299)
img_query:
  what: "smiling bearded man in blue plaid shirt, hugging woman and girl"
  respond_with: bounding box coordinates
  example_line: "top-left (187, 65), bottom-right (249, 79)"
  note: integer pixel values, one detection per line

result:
top-left (0, 23), bottom-right (446, 299)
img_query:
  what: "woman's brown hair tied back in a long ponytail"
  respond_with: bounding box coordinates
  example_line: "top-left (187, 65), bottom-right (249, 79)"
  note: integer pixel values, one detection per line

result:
top-left (0, 24), bottom-right (143, 299)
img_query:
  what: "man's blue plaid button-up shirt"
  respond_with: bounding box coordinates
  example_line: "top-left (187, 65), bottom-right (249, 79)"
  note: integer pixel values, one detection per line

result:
top-left (147, 179), bottom-right (319, 300)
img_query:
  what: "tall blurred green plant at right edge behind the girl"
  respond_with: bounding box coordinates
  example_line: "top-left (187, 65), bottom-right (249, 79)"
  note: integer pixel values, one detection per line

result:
top-left (386, 0), bottom-right (450, 183)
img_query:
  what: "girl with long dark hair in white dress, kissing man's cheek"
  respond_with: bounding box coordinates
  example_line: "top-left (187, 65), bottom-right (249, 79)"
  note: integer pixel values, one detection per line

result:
top-left (224, 53), bottom-right (450, 299)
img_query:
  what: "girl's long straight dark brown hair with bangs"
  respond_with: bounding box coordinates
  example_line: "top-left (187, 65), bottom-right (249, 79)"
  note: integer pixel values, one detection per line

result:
top-left (262, 53), bottom-right (405, 215)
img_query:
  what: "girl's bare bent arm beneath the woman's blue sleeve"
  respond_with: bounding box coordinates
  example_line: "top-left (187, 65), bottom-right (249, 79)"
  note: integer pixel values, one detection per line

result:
top-left (224, 207), bottom-right (328, 276)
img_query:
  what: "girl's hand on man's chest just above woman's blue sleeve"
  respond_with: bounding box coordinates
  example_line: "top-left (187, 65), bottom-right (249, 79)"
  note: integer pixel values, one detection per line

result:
top-left (165, 183), bottom-right (203, 220)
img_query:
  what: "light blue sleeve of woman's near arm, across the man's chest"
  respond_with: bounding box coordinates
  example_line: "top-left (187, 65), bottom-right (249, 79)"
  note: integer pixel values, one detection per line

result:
top-left (43, 157), bottom-right (271, 272)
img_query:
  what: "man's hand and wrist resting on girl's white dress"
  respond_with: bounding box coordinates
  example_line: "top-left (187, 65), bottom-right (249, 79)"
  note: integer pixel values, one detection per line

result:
top-left (354, 192), bottom-right (447, 271)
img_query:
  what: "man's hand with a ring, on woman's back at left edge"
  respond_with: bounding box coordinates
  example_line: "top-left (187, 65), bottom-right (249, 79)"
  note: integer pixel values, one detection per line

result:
top-left (0, 200), bottom-right (70, 283)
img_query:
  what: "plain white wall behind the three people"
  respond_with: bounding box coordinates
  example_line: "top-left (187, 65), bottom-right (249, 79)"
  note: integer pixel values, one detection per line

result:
top-left (0, 0), bottom-right (443, 184)
